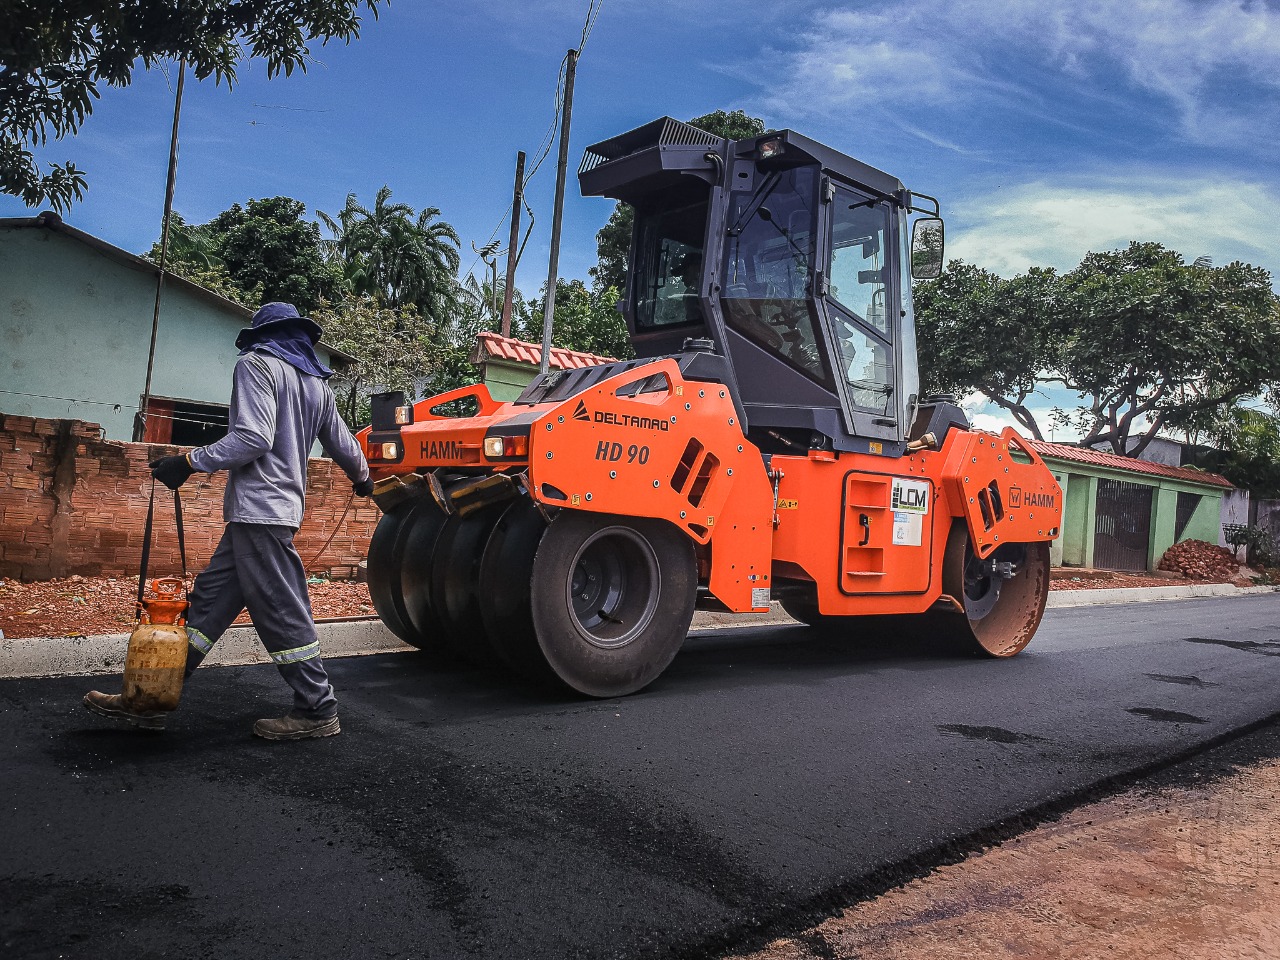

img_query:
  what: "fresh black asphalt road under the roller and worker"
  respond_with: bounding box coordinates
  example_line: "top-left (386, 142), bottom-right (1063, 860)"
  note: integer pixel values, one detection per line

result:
top-left (0, 595), bottom-right (1280, 960)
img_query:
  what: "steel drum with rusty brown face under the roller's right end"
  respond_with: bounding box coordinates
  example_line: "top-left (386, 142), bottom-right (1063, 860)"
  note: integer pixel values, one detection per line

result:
top-left (942, 524), bottom-right (1050, 657)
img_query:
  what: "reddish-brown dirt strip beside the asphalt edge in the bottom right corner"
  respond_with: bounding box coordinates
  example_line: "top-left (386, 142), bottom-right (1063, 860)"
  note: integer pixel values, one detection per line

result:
top-left (740, 726), bottom-right (1280, 960)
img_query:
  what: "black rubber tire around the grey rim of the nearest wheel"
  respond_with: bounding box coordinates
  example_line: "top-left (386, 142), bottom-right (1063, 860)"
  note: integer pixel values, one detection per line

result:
top-left (530, 509), bottom-right (698, 698)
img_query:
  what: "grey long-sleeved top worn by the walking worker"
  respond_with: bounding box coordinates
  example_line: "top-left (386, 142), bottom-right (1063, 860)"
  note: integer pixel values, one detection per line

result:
top-left (189, 351), bottom-right (369, 529)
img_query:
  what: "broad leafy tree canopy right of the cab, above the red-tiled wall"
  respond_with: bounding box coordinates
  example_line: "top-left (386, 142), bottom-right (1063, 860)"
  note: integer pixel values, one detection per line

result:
top-left (914, 248), bottom-right (1280, 456)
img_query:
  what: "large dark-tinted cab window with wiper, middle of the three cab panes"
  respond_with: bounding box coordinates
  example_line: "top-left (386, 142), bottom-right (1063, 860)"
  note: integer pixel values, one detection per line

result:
top-left (721, 166), bottom-right (831, 387)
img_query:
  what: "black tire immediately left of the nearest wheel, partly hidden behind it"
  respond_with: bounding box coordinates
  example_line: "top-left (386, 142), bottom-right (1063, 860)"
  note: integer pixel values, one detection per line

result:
top-left (479, 497), bottom-right (556, 684)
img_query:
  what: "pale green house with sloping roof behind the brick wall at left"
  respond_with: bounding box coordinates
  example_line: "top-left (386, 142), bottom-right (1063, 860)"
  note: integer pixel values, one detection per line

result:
top-left (0, 212), bottom-right (349, 444)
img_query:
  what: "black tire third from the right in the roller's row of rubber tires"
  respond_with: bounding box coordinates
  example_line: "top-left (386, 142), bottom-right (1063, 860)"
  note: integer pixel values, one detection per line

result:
top-left (431, 506), bottom-right (503, 667)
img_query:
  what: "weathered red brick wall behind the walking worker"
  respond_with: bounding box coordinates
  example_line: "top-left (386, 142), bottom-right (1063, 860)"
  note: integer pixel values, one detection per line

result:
top-left (0, 413), bottom-right (380, 580)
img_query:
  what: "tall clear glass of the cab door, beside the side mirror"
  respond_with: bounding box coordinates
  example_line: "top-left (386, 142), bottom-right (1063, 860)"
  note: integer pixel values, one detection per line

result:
top-left (828, 188), bottom-right (893, 413)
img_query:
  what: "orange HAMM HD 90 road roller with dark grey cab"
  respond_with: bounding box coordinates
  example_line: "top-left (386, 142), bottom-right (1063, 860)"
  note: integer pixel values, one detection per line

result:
top-left (360, 118), bottom-right (1062, 698)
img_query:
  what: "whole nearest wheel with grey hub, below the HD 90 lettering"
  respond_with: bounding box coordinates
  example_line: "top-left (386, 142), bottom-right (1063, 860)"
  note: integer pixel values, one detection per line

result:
top-left (530, 509), bottom-right (698, 698)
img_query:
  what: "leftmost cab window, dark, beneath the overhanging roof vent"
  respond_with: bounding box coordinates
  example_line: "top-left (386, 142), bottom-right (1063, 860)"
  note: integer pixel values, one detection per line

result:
top-left (634, 201), bottom-right (707, 329)
